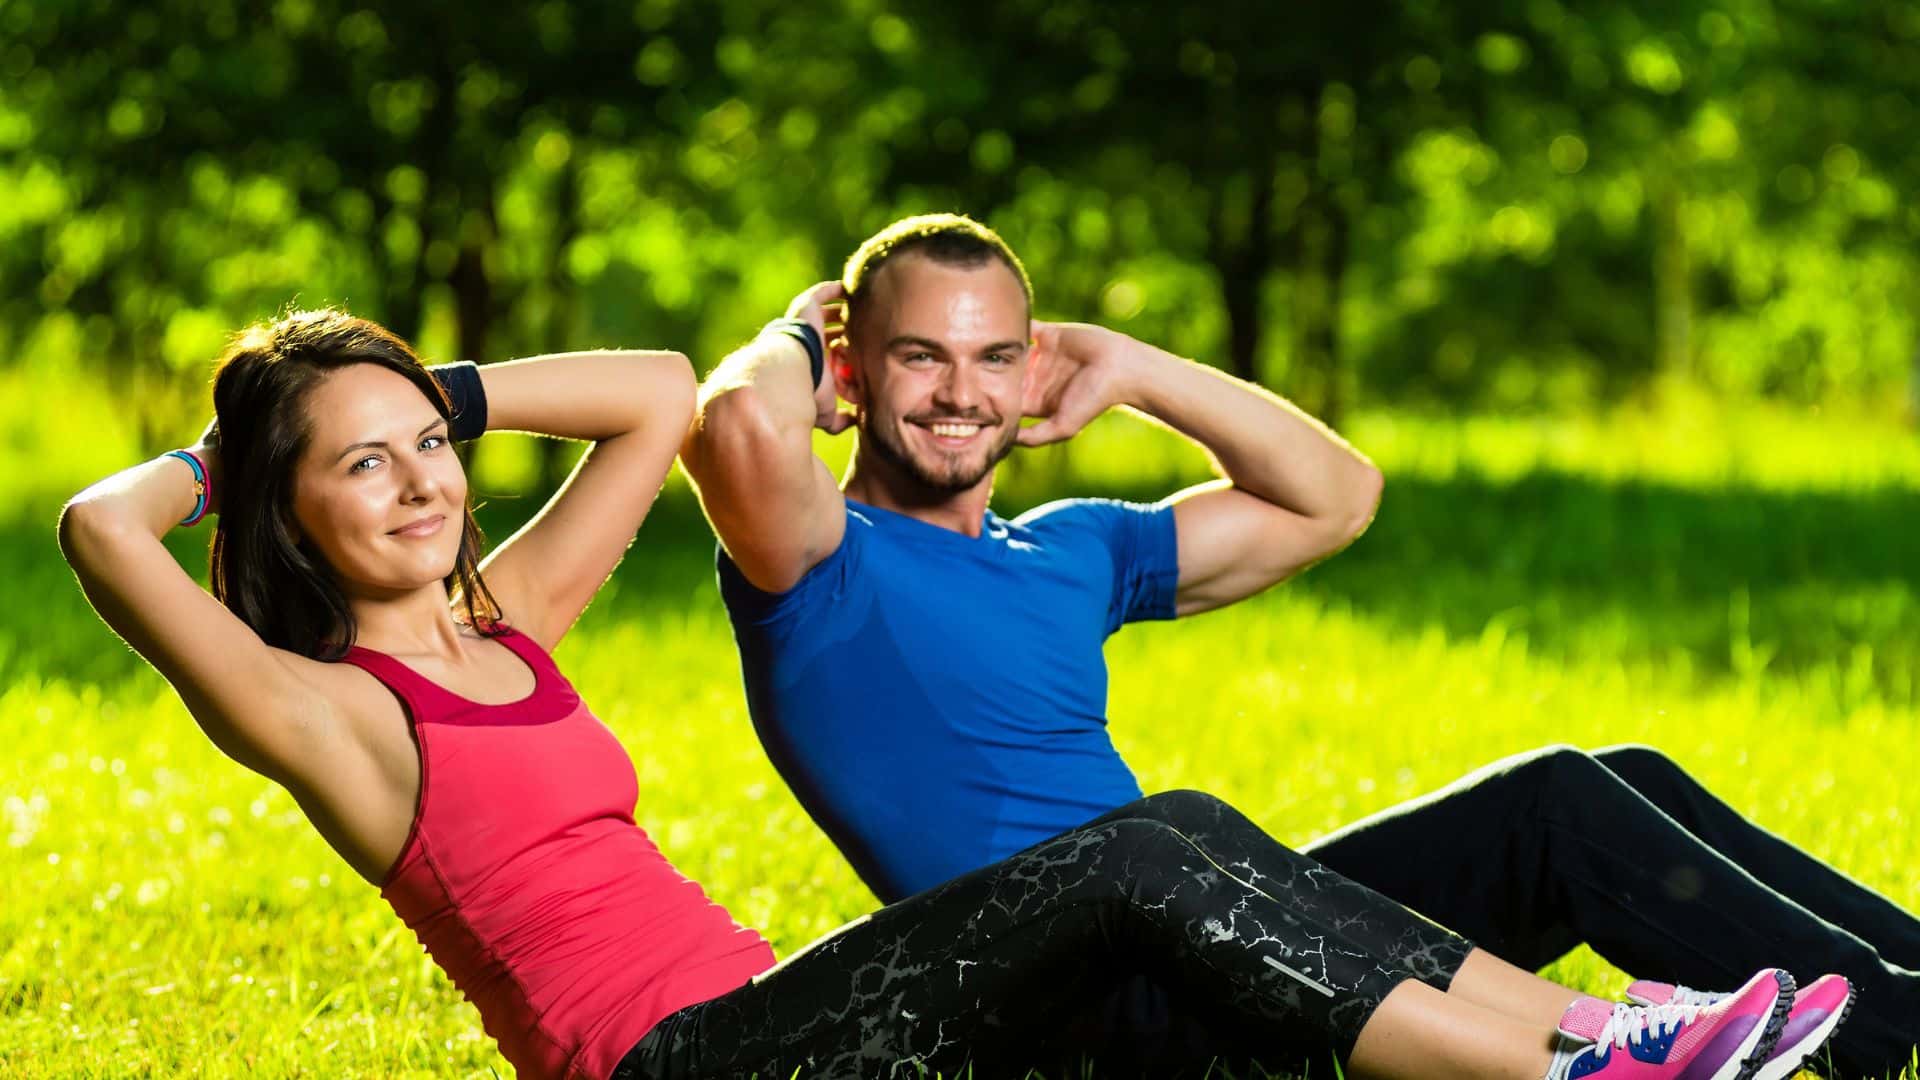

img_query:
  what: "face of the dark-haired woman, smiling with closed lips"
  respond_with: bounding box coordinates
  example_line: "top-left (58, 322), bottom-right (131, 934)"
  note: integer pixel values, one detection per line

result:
top-left (294, 363), bottom-right (467, 596)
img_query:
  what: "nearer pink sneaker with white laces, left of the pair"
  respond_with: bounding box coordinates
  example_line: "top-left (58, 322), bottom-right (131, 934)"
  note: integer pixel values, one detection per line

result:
top-left (1559, 969), bottom-right (1793, 1080)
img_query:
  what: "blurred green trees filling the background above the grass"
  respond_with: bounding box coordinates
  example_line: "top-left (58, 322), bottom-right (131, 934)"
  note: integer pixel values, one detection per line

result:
top-left (0, 0), bottom-right (1920, 453)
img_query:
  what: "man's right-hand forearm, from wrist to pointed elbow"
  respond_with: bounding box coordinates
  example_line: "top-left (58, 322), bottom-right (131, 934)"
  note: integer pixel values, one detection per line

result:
top-left (1129, 344), bottom-right (1379, 517)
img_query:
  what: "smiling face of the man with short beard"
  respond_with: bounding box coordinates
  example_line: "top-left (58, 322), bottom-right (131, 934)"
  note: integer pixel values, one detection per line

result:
top-left (841, 254), bottom-right (1029, 496)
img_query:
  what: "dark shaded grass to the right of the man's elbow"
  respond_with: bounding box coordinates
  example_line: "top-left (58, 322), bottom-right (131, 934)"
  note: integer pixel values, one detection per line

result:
top-left (1298, 473), bottom-right (1920, 705)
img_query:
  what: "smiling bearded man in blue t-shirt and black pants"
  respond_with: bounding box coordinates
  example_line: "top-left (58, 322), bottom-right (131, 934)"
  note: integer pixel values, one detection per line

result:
top-left (684, 215), bottom-right (1920, 1072)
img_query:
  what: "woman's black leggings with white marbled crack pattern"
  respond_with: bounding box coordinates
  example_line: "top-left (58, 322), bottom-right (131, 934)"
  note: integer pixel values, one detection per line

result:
top-left (614, 792), bottom-right (1471, 1080)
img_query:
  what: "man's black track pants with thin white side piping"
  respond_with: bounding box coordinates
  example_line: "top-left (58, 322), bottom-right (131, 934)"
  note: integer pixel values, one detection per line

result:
top-left (1306, 746), bottom-right (1920, 1076)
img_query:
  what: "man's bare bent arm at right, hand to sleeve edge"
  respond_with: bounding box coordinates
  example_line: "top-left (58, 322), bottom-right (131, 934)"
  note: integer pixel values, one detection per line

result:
top-left (1021, 323), bottom-right (1380, 615)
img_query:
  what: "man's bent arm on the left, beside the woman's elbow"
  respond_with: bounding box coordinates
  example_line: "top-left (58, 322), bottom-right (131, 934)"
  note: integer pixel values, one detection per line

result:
top-left (680, 282), bottom-right (852, 592)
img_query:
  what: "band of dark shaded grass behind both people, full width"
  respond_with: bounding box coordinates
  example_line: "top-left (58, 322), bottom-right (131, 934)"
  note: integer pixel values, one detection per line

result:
top-left (11, 473), bottom-right (1920, 705)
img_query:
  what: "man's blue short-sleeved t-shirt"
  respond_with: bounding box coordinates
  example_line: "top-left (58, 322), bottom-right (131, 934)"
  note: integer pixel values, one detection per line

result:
top-left (718, 500), bottom-right (1179, 901)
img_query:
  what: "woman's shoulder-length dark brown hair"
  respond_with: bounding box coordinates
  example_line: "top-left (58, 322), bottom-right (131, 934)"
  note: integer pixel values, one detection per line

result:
top-left (209, 309), bottom-right (501, 659)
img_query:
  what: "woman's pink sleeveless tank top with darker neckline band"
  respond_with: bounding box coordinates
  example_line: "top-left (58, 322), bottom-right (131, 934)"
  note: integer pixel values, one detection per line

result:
top-left (346, 630), bottom-right (774, 1080)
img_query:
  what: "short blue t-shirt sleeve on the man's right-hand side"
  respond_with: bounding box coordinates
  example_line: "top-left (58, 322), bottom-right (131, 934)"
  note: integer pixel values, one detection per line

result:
top-left (1020, 500), bottom-right (1181, 634)
